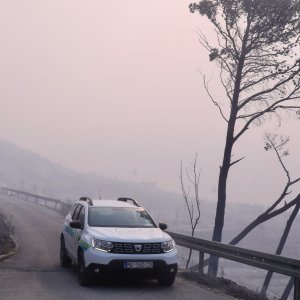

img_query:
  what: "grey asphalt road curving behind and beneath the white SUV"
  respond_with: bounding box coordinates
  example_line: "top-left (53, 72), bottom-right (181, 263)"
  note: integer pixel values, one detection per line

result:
top-left (0, 195), bottom-right (233, 300)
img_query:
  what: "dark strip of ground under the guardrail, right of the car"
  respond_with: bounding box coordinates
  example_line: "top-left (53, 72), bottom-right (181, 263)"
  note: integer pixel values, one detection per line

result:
top-left (178, 271), bottom-right (268, 300)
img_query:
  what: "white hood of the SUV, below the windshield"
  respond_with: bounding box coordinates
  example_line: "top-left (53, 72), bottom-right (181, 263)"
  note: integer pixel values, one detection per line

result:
top-left (89, 227), bottom-right (171, 243)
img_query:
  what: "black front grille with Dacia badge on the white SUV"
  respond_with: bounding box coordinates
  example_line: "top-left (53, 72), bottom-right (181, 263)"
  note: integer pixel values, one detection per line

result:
top-left (111, 243), bottom-right (163, 254)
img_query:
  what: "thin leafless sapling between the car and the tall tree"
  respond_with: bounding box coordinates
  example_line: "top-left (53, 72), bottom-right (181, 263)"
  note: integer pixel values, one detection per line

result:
top-left (179, 153), bottom-right (201, 269)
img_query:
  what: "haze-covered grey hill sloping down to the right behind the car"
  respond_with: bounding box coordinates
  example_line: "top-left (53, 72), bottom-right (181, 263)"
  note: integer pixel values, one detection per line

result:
top-left (0, 141), bottom-right (180, 206)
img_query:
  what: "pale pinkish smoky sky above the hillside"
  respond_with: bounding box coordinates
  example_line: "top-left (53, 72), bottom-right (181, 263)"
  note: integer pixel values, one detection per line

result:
top-left (0, 0), bottom-right (300, 203)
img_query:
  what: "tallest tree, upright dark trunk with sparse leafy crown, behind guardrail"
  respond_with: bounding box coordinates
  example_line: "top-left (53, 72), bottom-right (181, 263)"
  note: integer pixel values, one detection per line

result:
top-left (189, 0), bottom-right (300, 276)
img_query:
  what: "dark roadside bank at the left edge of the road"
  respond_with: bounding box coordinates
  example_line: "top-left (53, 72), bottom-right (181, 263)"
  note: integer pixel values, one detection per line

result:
top-left (0, 211), bottom-right (17, 261)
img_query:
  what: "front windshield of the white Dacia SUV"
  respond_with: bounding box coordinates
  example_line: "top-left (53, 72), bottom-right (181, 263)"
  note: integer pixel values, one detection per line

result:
top-left (88, 207), bottom-right (156, 228)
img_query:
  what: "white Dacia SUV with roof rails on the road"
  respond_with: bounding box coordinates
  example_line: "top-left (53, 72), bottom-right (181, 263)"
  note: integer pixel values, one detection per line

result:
top-left (60, 197), bottom-right (177, 286)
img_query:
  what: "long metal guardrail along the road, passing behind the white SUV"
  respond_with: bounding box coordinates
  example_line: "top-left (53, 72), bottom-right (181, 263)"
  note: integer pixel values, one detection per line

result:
top-left (1, 187), bottom-right (300, 300)
